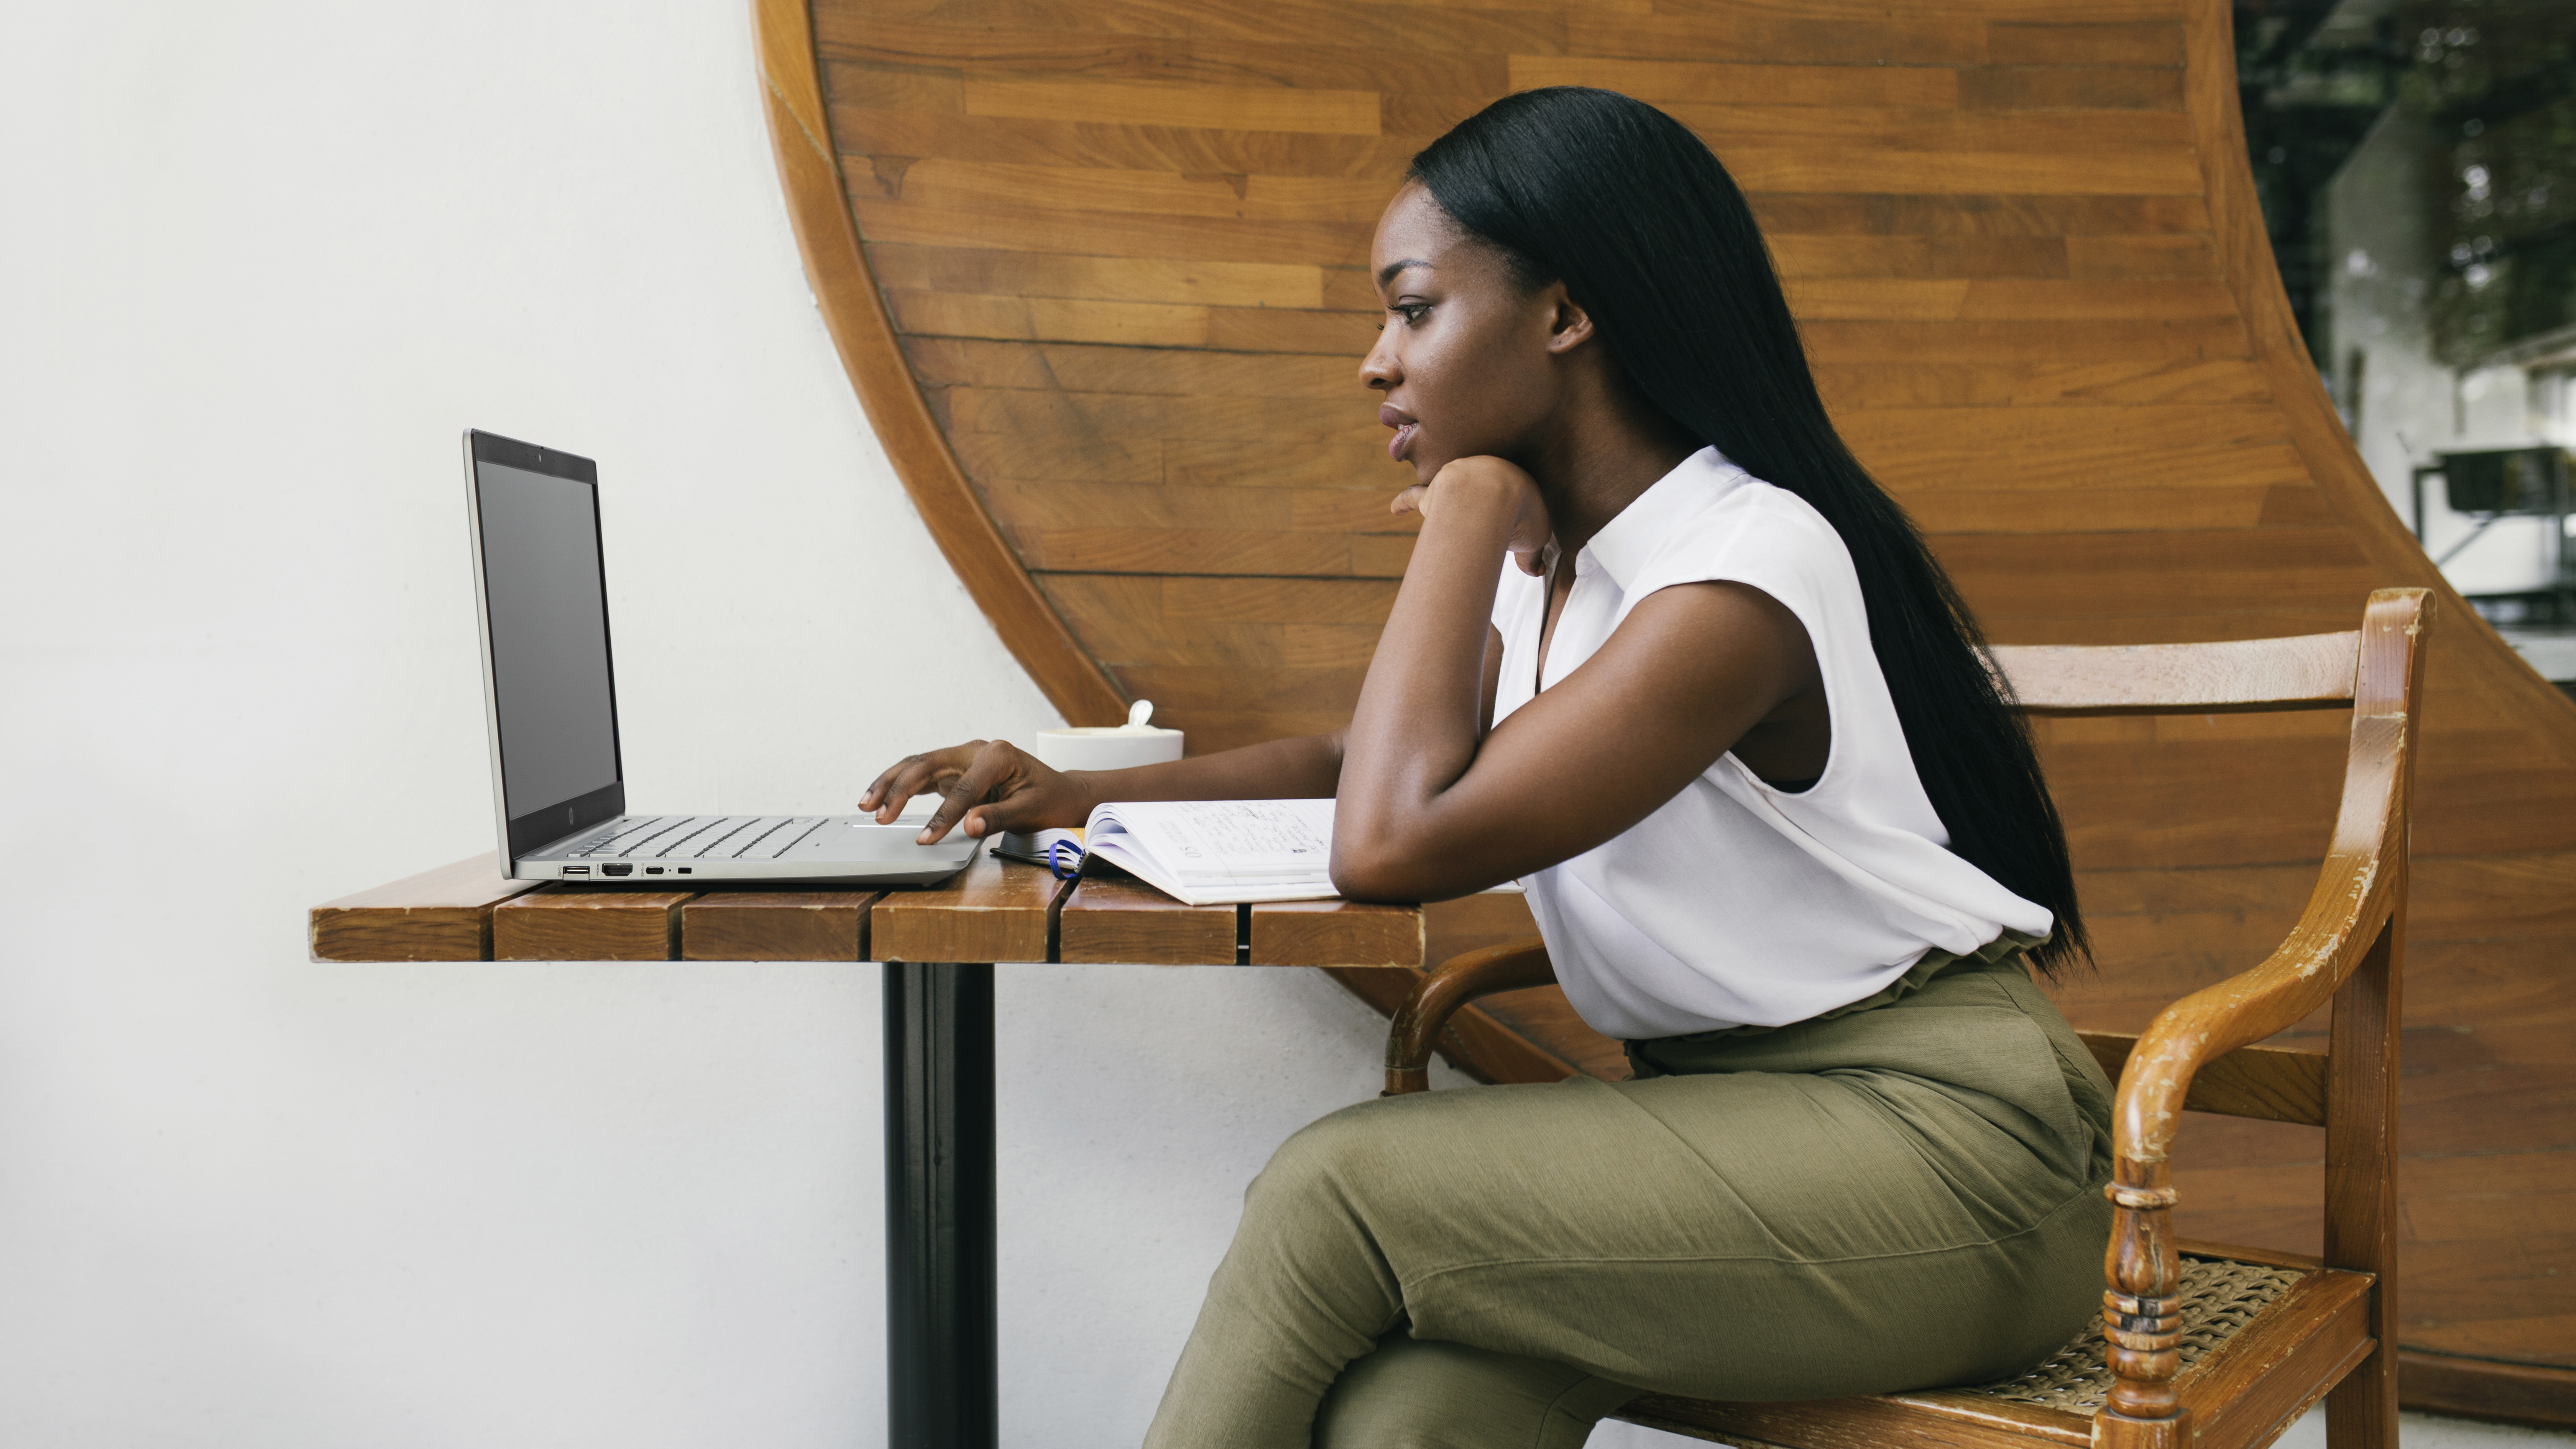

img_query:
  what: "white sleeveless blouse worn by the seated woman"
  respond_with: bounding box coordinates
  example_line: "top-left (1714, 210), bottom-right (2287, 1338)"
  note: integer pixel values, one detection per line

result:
top-left (1494, 449), bottom-right (2050, 1039)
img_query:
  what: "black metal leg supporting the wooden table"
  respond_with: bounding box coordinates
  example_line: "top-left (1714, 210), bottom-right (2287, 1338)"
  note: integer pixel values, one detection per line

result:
top-left (886, 962), bottom-right (999, 1449)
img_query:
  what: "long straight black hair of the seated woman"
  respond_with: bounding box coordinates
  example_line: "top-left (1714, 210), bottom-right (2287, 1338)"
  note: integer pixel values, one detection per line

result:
top-left (1409, 85), bottom-right (2092, 977)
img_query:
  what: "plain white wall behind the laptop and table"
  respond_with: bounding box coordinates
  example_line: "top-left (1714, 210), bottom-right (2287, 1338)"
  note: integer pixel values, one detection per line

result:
top-left (0, 0), bottom-right (1463, 1449)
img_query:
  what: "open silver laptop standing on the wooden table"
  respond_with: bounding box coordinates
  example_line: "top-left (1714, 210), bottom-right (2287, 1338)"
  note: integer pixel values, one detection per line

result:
top-left (466, 430), bottom-right (976, 889)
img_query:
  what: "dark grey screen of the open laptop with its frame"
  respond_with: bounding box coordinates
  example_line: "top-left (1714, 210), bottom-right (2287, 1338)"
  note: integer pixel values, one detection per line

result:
top-left (474, 433), bottom-right (626, 856)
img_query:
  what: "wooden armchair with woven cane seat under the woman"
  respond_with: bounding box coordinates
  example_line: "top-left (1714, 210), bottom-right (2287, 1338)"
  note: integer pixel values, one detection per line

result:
top-left (1386, 588), bottom-right (2432, 1449)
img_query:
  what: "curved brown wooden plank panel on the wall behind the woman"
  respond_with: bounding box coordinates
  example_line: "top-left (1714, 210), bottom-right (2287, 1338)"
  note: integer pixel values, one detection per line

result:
top-left (757, 0), bottom-right (2576, 1413)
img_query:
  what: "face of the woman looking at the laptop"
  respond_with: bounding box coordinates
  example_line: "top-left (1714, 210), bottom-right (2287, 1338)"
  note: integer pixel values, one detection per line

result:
top-left (1360, 183), bottom-right (1592, 482)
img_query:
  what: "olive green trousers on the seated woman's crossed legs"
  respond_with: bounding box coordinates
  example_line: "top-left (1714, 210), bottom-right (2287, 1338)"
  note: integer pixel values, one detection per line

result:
top-left (1146, 941), bottom-right (2110, 1449)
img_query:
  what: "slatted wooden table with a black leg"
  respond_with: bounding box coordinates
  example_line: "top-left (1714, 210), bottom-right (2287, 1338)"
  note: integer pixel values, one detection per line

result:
top-left (312, 856), bottom-right (1424, 1449)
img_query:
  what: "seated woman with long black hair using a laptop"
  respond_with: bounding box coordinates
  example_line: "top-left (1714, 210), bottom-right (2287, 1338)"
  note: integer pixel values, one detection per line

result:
top-left (860, 88), bottom-right (2110, 1449)
